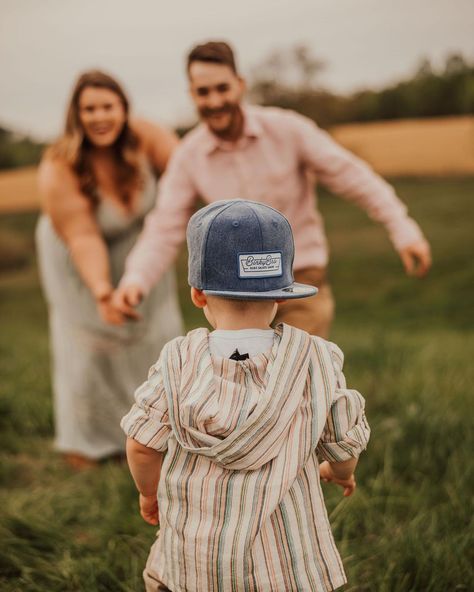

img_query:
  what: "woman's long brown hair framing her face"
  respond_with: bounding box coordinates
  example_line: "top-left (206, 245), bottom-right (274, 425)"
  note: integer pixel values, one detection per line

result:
top-left (46, 70), bottom-right (143, 206)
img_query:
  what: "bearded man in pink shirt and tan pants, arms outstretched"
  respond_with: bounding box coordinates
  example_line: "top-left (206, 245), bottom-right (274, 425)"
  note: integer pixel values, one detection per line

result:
top-left (114, 42), bottom-right (431, 337)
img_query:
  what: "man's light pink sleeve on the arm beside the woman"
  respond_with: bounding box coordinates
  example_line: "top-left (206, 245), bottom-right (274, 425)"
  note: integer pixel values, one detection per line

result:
top-left (120, 146), bottom-right (197, 293)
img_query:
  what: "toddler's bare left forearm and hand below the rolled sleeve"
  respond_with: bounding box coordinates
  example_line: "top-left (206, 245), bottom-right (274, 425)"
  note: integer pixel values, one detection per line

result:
top-left (127, 438), bottom-right (163, 525)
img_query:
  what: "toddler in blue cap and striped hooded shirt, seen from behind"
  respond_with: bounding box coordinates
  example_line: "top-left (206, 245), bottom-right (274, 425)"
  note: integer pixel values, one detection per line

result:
top-left (121, 200), bottom-right (370, 592)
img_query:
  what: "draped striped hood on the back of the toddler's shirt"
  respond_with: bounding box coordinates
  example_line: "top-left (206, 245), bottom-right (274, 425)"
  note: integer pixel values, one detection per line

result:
top-left (163, 325), bottom-right (313, 470)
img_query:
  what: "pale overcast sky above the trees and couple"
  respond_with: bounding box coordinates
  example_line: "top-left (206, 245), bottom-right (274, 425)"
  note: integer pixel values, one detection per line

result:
top-left (0, 0), bottom-right (474, 138)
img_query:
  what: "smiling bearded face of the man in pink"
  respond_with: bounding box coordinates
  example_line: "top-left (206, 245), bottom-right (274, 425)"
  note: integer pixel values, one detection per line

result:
top-left (189, 62), bottom-right (245, 139)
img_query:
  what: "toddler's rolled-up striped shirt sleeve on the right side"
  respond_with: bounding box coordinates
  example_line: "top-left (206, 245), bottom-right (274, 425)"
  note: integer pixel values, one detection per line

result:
top-left (316, 343), bottom-right (370, 462)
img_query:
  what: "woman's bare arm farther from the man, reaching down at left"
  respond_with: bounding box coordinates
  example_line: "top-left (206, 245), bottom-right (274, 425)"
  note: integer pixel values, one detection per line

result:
top-left (38, 159), bottom-right (129, 324)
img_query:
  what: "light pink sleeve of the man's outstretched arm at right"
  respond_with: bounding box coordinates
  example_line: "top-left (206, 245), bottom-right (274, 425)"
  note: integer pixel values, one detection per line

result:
top-left (288, 113), bottom-right (424, 249)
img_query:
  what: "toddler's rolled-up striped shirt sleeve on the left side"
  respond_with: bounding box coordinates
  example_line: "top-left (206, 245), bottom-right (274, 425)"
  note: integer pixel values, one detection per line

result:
top-left (120, 360), bottom-right (171, 452)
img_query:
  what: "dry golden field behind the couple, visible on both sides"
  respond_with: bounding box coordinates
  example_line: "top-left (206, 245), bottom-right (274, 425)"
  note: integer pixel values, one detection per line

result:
top-left (0, 117), bottom-right (474, 213)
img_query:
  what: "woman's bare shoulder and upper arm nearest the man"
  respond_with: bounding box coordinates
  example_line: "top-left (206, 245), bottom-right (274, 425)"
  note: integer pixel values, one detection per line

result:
top-left (131, 119), bottom-right (179, 173)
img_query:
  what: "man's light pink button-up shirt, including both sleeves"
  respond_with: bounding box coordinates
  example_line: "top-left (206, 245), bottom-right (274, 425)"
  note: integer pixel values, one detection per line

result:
top-left (121, 106), bottom-right (423, 291)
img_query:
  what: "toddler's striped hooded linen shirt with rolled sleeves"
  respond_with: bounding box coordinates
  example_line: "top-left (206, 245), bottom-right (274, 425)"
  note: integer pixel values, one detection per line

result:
top-left (122, 325), bottom-right (370, 592)
